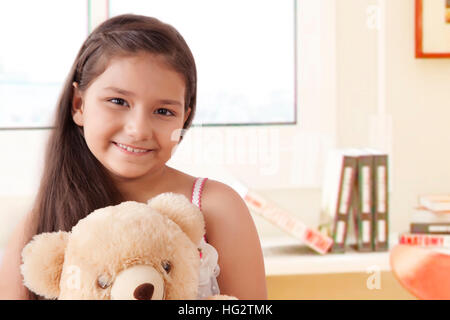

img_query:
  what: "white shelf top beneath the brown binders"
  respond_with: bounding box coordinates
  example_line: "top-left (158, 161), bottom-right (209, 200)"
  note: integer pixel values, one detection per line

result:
top-left (261, 235), bottom-right (397, 276)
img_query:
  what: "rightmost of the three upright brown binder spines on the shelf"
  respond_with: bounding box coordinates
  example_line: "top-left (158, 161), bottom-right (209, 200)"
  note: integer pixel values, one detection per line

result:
top-left (372, 155), bottom-right (389, 251)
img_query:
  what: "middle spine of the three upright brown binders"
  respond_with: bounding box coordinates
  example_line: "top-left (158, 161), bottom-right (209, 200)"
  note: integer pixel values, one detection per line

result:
top-left (356, 156), bottom-right (374, 252)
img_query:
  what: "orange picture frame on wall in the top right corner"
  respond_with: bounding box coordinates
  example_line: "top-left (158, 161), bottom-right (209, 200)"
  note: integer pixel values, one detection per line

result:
top-left (415, 0), bottom-right (450, 58)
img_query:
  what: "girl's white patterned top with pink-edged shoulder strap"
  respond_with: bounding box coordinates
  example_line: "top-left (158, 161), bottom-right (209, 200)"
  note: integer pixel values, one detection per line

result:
top-left (191, 178), bottom-right (220, 299)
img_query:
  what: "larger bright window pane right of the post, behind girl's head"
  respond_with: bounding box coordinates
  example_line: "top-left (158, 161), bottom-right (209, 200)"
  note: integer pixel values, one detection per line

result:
top-left (109, 0), bottom-right (296, 126)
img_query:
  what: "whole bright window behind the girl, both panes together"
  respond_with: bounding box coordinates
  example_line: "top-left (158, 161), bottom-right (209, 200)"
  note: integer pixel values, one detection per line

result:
top-left (0, 0), bottom-right (297, 128)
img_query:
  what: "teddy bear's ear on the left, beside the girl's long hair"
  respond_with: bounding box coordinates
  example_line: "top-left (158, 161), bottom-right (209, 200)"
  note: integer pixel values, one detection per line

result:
top-left (20, 231), bottom-right (69, 299)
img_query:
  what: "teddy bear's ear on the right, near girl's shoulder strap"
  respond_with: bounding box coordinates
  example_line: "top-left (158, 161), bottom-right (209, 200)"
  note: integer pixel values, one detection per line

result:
top-left (147, 192), bottom-right (205, 245)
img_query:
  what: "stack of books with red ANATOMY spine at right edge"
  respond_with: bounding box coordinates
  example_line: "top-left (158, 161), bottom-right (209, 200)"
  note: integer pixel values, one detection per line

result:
top-left (399, 194), bottom-right (450, 249)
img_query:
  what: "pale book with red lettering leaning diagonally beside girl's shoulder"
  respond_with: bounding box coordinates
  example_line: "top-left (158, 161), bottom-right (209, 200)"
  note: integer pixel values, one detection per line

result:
top-left (244, 191), bottom-right (333, 254)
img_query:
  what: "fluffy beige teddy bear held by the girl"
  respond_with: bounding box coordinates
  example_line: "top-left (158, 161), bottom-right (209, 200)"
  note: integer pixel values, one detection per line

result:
top-left (20, 192), bottom-right (236, 300)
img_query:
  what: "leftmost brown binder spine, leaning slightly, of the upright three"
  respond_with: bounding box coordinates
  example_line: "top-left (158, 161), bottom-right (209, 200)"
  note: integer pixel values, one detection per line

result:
top-left (332, 156), bottom-right (358, 252)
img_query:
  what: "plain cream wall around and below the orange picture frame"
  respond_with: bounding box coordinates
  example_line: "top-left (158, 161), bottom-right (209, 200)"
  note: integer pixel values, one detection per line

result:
top-left (386, 0), bottom-right (450, 235)
